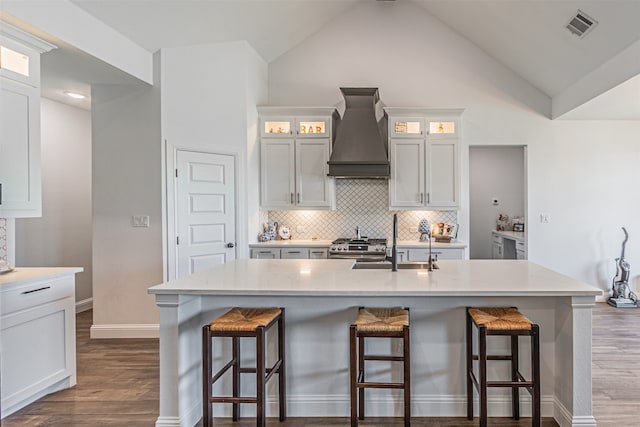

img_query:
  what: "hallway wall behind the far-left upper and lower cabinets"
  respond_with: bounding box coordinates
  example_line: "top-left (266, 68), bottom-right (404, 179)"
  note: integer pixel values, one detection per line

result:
top-left (15, 98), bottom-right (92, 302)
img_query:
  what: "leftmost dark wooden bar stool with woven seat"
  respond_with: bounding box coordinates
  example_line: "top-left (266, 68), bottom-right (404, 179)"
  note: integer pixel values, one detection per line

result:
top-left (202, 307), bottom-right (286, 427)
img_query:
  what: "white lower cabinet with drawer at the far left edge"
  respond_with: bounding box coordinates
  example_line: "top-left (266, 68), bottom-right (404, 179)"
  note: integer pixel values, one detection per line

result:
top-left (0, 275), bottom-right (76, 417)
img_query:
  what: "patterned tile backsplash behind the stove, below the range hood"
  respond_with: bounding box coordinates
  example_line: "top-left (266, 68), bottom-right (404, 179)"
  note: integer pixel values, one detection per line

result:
top-left (267, 179), bottom-right (458, 240)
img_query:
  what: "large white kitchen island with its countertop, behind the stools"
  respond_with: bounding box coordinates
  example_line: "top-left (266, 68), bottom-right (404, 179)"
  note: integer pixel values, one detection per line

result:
top-left (149, 259), bottom-right (601, 427)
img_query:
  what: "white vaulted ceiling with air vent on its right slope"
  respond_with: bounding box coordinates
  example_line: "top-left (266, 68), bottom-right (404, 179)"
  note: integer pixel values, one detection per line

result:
top-left (1, 0), bottom-right (640, 119)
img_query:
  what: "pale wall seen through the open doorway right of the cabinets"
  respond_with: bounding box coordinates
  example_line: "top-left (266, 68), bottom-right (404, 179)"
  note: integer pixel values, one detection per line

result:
top-left (469, 145), bottom-right (533, 259)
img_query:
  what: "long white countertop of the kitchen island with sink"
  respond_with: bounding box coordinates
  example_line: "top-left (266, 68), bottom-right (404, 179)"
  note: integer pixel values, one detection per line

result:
top-left (148, 259), bottom-right (602, 296)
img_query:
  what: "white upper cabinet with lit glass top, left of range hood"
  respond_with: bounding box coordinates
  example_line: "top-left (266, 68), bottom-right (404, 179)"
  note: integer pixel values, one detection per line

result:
top-left (259, 107), bottom-right (335, 210)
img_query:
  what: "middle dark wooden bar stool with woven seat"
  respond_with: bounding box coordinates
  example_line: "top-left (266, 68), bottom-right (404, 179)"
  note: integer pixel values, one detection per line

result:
top-left (349, 307), bottom-right (411, 426)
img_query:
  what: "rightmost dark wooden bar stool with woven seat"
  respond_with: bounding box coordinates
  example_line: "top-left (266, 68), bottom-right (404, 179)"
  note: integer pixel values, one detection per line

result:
top-left (466, 307), bottom-right (541, 427)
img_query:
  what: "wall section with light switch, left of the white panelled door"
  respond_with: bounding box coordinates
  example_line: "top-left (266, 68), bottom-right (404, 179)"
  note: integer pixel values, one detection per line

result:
top-left (91, 77), bottom-right (162, 337)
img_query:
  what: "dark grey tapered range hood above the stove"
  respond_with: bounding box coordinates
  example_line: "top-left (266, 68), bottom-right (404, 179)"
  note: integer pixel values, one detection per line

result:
top-left (328, 88), bottom-right (390, 179)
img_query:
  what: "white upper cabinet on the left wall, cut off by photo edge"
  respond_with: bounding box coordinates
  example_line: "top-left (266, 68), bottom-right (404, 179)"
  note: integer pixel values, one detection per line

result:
top-left (0, 22), bottom-right (55, 218)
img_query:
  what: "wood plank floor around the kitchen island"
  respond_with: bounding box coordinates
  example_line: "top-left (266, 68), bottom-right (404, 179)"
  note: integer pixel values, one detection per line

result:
top-left (2, 304), bottom-right (640, 427)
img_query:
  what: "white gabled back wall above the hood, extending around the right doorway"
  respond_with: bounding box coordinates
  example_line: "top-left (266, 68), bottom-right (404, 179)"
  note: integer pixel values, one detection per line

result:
top-left (269, 2), bottom-right (640, 296)
